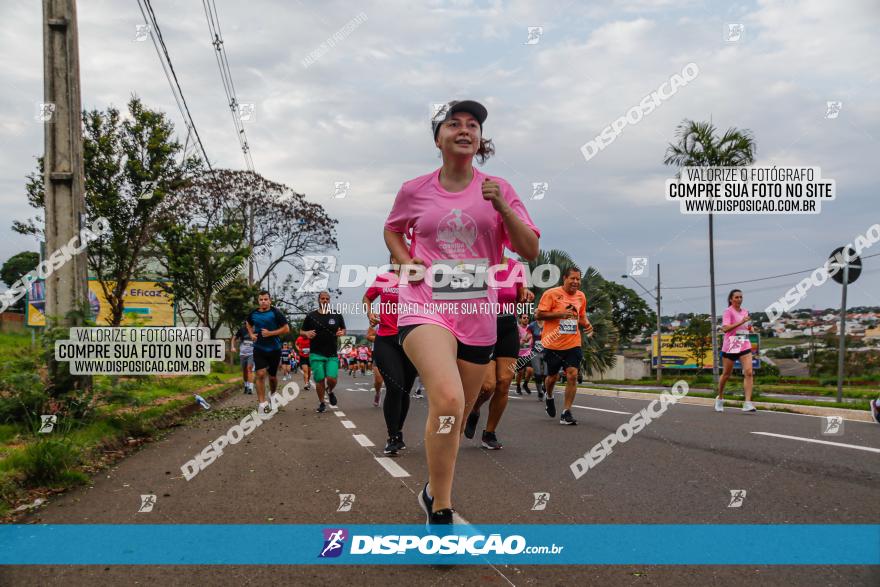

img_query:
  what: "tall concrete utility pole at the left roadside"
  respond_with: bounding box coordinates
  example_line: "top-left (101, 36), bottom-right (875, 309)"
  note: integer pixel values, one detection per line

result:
top-left (40, 0), bottom-right (90, 387)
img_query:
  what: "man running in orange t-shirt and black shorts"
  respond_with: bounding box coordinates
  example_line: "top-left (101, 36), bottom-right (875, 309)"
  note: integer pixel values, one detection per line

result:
top-left (535, 267), bottom-right (593, 426)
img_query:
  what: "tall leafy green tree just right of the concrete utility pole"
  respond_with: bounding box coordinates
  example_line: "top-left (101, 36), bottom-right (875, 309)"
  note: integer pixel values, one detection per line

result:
top-left (13, 97), bottom-right (201, 326)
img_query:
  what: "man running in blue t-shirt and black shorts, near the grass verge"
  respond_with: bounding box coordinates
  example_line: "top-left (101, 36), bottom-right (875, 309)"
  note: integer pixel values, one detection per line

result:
top-left (245, 290), bottom-right (290, 414)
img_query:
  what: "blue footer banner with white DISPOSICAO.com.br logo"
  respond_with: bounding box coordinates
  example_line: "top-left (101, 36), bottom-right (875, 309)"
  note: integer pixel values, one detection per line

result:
top-left (0, 524), bottom-right (880, 565)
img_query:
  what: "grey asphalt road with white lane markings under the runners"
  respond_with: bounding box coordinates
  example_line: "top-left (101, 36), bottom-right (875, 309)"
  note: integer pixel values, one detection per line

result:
top-left (0, 376), bottom-right (880, 585)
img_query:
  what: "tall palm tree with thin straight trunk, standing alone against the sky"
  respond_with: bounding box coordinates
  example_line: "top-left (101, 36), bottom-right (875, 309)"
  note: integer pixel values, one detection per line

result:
top-left (663, 119), bottom-right (757, 390)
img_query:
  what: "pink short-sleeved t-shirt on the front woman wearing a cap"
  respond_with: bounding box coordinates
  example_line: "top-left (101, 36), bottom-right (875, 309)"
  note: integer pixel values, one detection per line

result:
top-left (385, 168), bottom-right (540, 346)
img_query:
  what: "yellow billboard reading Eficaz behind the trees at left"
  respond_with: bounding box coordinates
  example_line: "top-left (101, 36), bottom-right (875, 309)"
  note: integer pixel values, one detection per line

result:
top-left (25, 279), bottom-right (175, 326)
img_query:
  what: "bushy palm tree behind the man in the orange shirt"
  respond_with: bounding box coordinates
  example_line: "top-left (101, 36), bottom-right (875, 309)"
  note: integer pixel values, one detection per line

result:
top-left (520, 249), bottom-right (618, 375)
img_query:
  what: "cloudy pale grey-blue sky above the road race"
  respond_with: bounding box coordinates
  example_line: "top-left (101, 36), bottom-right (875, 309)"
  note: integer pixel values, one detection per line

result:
top-left (0, 0), bottom-right (880, 326)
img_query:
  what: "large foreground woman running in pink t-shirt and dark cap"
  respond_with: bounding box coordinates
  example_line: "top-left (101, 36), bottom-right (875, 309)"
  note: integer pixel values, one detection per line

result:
top-left (384, 101), bottom-right (540, 524)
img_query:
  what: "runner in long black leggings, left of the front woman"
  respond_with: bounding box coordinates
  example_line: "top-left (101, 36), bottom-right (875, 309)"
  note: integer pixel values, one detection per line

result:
top-left (363, 258), bottom-right (416, 455)
